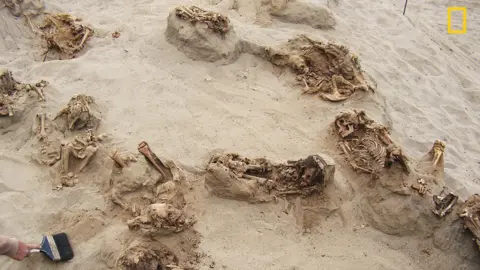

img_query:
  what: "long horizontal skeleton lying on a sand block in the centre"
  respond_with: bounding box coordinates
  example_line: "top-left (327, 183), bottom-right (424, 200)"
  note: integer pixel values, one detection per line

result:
top-left (205, 153), bottom-right (335, 203)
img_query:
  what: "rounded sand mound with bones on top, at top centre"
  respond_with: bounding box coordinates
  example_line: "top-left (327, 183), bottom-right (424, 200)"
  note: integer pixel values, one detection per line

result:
top-left (165, 6), bottom-right (240, 63)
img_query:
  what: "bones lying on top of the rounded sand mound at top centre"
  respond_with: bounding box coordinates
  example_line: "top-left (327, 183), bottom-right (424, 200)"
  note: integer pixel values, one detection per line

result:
top-left (175, 6), bottom-right (230, 35)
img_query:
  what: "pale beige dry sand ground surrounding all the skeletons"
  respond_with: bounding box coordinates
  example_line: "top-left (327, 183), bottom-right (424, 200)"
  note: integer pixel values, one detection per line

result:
top-left (0, 0), bottom-right (480, 270)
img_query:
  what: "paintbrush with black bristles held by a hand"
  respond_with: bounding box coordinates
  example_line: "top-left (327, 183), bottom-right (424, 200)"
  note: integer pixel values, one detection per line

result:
top-left (30, 233), bottom-right (74, 262)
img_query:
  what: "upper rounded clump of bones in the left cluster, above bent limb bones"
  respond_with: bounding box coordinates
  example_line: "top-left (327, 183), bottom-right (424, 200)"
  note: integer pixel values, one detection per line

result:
top-left (53, 94), bottom-right (100, 130)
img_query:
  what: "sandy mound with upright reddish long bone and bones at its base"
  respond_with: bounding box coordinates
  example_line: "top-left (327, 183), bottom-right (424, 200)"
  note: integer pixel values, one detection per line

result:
top-left (110, 142), bottom-right (195, 236)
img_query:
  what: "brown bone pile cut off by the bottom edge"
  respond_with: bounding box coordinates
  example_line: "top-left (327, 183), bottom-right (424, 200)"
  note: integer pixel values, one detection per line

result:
top-left (116, 241), bottom-right (183, 270)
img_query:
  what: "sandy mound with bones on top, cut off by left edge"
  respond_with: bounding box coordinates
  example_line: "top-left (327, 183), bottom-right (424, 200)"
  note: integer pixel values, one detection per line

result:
top-left (0, 69), bottom-right (48, 128)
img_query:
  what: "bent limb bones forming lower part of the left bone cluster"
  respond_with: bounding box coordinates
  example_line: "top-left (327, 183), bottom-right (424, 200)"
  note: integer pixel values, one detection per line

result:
top-left (61, 129), bottom-right (105, 174)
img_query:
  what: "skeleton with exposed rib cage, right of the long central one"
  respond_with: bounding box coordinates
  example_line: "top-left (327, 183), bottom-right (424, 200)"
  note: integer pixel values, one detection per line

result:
top-left (334, 110), bottom-right (410, 174)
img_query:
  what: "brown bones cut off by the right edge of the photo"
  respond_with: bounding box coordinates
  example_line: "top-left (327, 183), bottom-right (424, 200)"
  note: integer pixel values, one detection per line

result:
top-left (459, 194), bottom-right (480, 248)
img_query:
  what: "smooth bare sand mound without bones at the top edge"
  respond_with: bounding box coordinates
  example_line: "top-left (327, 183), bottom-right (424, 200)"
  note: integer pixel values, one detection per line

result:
top-left (270, 0), bottom-right (336, 29)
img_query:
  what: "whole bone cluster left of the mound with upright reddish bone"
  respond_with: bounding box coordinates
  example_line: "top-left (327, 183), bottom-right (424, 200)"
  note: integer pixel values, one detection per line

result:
top-left (32, 94), bottom-right (107, 188)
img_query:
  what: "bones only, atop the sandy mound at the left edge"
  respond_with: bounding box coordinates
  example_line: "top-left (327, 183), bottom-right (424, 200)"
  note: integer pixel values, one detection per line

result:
top-left (0, 69), bottom-right (48, 116)
